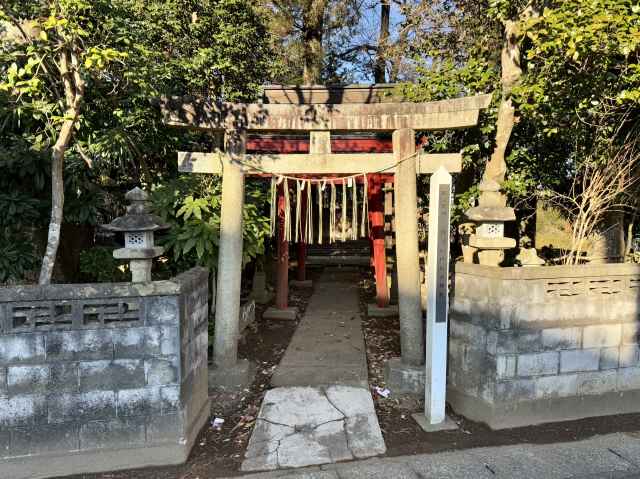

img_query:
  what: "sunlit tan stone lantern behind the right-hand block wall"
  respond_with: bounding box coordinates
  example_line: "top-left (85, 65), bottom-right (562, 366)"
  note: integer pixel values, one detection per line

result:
top-left (466, 180), bottom-right (516, 266)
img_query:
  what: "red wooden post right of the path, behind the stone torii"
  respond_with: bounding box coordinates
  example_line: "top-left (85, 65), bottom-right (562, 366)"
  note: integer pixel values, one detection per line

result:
top-left (367, 175), bottom-right (389, 308)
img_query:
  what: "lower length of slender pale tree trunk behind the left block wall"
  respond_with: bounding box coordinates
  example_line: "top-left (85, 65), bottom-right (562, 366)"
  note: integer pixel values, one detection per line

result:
top-left (38, 111), bottom-right (78, 284)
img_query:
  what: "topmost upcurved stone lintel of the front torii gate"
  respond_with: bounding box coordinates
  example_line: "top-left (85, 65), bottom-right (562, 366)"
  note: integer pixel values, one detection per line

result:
top-left (160, 87), bottom-right (491, 133)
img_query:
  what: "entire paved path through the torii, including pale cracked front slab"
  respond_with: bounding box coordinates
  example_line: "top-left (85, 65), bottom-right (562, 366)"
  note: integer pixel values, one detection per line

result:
top-left (242, 269), bottom-right (386, 471)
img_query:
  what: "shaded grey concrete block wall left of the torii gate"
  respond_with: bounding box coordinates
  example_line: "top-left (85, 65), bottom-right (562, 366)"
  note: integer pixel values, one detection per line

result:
top-left (0, 268), bottom-right (209, 479)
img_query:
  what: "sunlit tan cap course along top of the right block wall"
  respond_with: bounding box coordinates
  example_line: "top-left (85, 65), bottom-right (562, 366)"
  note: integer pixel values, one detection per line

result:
top-left (455, 262), bottom-right (640, 280)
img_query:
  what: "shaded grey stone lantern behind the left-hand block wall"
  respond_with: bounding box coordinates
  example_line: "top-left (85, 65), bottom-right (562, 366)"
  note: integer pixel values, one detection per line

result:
top-left (103, 187), bottom-right (169, 283)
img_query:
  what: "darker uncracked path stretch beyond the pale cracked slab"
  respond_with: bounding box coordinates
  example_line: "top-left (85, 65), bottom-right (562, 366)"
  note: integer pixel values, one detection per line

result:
top-left (271, 268), bottom-right (368, 388)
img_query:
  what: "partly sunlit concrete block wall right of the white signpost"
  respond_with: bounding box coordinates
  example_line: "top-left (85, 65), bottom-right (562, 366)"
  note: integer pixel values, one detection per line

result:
top-left (448, 263), bottom-right (640, 428)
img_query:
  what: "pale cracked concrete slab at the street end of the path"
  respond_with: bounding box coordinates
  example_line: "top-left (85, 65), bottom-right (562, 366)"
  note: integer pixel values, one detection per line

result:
top-left (242, 385), bottom-right (386, 471)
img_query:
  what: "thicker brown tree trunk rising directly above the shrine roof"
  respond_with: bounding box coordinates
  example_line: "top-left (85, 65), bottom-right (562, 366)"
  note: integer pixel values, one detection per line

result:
top-left (302, 0), bottom-right (327, 85)
